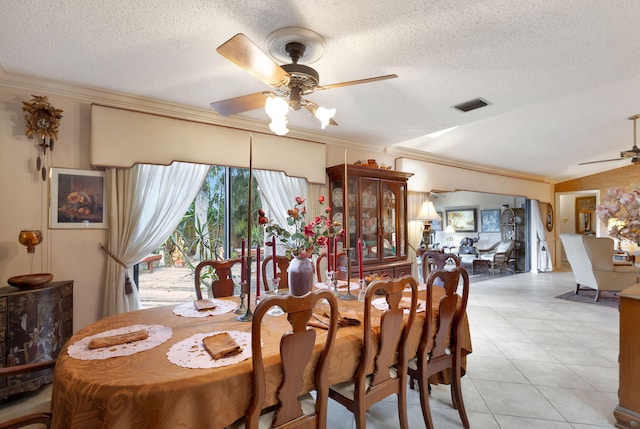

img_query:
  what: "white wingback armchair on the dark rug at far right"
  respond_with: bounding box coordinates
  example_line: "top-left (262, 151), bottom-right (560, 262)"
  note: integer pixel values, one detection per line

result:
top-left (560, 234), bottom-right (640, 301)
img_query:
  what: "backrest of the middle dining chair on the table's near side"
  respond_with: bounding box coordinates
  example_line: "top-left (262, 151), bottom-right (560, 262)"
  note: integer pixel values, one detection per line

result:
top-left (354, 276), bottom-right (418, 390)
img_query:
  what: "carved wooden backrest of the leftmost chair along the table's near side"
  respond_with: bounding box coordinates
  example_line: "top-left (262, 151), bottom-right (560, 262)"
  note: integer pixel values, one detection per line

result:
top-left (245, 290), bottom-right (340, 429)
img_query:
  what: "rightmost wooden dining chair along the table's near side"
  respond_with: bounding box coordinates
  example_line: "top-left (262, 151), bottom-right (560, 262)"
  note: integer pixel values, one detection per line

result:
top-left (408, 267), bottom-right (469, 429)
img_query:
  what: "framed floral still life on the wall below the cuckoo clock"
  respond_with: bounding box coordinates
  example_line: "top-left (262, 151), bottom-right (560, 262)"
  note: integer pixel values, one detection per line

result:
top-left (49, 168), bottom-right (107, 229)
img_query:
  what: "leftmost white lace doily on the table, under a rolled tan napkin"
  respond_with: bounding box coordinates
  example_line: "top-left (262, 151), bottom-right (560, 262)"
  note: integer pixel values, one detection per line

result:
top-left (67, 325), bottom-right (173, 360)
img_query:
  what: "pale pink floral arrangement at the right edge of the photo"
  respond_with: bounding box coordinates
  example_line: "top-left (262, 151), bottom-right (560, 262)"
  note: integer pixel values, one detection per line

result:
top-left (596, 186), bottom-right (640, 244)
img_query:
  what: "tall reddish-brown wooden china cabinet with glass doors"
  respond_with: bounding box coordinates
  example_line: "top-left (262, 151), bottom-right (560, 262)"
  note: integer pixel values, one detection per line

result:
top-left (327, 164), bottom-right (413, 277)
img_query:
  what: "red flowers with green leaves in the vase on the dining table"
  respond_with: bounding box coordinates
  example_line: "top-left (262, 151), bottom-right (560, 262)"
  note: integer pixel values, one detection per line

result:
top-left (258, 196), bottom-right (342, 258)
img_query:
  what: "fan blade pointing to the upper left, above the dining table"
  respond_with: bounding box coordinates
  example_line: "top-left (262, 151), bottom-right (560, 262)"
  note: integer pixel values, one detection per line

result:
top-left (217, 33), bottom-right (291, 88)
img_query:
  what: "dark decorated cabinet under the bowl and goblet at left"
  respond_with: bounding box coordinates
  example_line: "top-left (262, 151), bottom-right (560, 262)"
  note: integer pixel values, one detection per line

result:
top-left (0, 280), bottom-right (73, 398)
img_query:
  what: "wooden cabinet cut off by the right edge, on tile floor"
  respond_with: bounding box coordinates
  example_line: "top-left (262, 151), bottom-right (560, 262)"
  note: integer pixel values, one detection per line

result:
top-left (613, 284), bottom-right (640, 429)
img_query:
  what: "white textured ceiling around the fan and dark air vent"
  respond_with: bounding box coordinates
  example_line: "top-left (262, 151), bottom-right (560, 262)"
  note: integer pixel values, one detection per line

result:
top-left (0, 0), bottom-right (640, 180)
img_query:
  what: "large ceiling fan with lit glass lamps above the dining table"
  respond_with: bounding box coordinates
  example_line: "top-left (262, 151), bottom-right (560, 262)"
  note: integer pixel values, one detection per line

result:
top-left (211, 27), bottom-right (398, 135)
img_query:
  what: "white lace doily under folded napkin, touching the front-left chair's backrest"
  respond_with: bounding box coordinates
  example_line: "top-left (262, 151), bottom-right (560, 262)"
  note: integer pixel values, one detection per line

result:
top-left (167, 331), bottom-right (251, 368)
